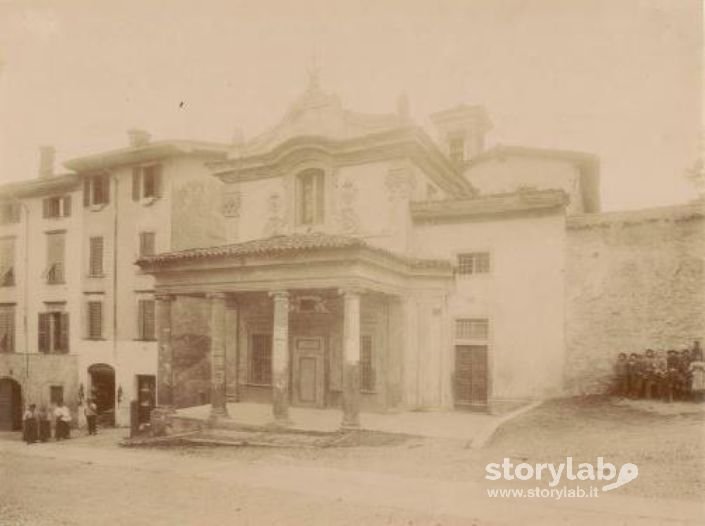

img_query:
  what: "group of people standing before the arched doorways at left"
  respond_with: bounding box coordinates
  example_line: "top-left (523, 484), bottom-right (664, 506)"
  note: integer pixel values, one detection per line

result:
top-left (22, 399), bottom-right (98, 444)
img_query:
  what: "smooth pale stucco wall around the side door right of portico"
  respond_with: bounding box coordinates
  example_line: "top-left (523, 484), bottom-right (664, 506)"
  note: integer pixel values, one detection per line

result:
top-left (415, 214), bottom-right (565, 399)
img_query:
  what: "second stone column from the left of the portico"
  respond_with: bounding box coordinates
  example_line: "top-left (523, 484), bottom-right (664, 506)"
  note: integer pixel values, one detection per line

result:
top-left (207, 292), bottom-right (228, 419)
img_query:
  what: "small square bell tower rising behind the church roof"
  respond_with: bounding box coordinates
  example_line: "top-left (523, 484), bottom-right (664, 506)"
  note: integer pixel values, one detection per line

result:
top-left (431, 104), bottom-right (492, 165)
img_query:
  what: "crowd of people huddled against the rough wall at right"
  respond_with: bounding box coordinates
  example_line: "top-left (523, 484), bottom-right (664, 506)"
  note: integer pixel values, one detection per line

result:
top-left (614, 341), bottom-right (705, 402)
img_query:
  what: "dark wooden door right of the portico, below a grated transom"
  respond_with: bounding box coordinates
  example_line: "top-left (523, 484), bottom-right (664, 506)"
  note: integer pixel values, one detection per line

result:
top-left (455, 345), bottom-right (487, 407)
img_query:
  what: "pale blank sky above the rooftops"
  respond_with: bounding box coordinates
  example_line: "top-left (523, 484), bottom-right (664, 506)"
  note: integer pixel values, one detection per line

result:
top-left (0, 0), bottom-right (703, 210)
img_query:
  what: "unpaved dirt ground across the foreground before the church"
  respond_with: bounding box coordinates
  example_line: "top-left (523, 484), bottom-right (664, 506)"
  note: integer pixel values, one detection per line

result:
top-left (0, 399), bottom-right (704, 526)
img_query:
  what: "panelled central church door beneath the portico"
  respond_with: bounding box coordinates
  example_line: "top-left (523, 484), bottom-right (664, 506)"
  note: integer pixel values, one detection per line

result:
top-left (292, 337), bottom-right (324, 407)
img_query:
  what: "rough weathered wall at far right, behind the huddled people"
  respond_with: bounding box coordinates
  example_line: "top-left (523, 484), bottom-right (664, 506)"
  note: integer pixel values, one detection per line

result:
top-left (566, 205), bottom-right (705, 393)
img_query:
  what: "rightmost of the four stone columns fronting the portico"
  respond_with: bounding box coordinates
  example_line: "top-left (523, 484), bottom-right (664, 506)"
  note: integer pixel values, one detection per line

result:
top-left (341, 290), bottom-right (360, 429)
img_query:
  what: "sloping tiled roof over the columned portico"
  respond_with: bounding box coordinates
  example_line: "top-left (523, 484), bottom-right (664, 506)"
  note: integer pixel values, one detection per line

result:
top-left (137, 233), bottom-right (450, 268)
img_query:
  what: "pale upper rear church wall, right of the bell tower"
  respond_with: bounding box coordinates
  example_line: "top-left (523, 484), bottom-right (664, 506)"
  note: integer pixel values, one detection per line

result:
top-left (464, 157), bottom-right (583, 214)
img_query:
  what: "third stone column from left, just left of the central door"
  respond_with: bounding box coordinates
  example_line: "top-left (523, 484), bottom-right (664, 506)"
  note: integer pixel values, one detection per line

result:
top-left (269, 291), bottom-right (290, 425)
